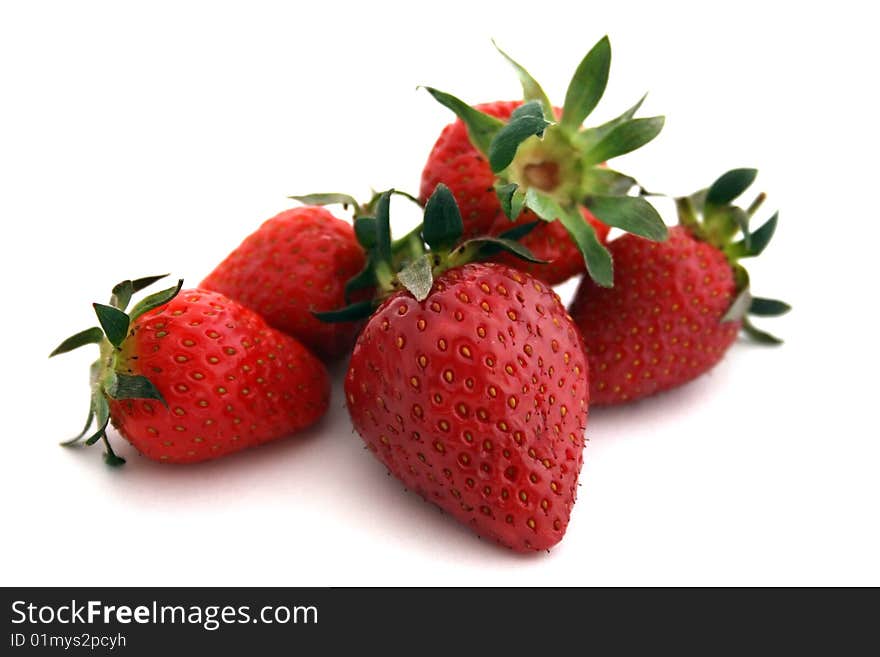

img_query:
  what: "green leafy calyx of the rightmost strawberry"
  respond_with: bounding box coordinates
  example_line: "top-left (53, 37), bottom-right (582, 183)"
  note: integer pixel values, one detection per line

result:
top-left (675, 169), bottom-right (791, 344)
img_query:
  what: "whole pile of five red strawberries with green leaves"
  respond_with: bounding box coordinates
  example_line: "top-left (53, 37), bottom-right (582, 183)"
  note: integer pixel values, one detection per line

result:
top-left (52, 38), bottom-right (789, 551)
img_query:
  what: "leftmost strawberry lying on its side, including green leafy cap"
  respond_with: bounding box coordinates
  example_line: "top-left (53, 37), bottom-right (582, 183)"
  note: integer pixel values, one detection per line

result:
top-left (51, 277), bottom-right (330, 465)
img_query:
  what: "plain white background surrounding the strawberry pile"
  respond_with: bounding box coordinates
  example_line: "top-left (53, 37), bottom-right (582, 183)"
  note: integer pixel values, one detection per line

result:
top-left (0, 0), bottom-right (880, 585)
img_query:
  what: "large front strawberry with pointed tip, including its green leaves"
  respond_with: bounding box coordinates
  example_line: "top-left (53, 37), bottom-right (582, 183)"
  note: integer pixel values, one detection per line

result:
top-left (326, 185), bottom-right (589, 551)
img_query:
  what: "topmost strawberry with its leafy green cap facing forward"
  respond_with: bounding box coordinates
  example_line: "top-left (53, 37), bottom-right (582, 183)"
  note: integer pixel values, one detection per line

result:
top-left (421, 38), bottom-right (666, 286)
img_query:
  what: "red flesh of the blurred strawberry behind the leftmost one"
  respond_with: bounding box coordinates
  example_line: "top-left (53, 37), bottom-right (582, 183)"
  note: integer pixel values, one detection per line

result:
top-left (201, 206), bottom-right (365, 358)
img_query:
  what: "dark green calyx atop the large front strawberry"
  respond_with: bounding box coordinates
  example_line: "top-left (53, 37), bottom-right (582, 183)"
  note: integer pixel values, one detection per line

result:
top-left (314, 184), bottom-right (544, 322)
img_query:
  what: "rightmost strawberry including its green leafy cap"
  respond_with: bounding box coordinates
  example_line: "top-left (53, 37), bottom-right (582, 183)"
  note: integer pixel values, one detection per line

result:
top-left (571, 169), bottom-right (789, 405)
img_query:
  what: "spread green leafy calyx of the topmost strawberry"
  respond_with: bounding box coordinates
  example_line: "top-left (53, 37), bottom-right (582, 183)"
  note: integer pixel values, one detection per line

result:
top-left (426, 37), bottom-right (667, 287)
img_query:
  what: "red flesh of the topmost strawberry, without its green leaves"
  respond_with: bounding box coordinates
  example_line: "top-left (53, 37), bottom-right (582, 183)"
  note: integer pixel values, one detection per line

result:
top-left (419, 101), bottom-right (609, 285)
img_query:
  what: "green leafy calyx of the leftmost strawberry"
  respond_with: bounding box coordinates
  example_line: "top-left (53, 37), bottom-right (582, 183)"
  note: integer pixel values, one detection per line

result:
top-left (49, 274), bottom-right (183, 466)
